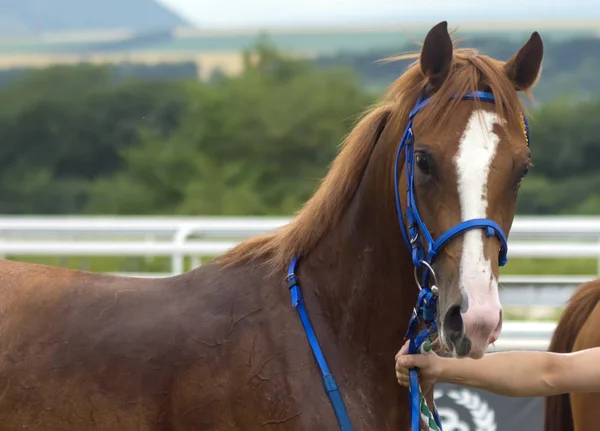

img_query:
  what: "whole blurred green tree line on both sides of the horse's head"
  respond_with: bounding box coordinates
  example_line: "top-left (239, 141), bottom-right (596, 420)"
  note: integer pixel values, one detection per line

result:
top-left (0, 40), bottom-right (600, 221)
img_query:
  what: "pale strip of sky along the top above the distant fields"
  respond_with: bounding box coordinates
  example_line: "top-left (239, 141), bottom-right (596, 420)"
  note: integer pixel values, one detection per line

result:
top-left (157, 0), bottom-right (600, 28)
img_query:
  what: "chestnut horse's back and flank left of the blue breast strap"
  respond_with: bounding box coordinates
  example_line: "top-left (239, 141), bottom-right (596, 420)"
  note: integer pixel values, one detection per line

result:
top-left (0, 261), bottom-right (338, 430)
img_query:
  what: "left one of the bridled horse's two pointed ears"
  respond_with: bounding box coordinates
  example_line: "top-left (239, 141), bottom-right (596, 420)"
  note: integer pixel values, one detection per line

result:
top-left (421, 21), bottom-right (454, 90)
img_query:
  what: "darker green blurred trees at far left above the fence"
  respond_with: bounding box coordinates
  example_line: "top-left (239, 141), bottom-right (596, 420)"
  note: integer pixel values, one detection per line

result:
top-left (0, 65), bottom-right (192, 214)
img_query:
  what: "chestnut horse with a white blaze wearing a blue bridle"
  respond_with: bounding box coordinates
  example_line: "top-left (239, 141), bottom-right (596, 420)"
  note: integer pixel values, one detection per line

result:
top-left (0, 22), bottom-right (543, 431)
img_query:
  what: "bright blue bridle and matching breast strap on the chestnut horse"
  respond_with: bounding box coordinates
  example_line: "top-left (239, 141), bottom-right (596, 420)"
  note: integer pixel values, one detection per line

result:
top-left (286, 91), bottom-right (529, 431)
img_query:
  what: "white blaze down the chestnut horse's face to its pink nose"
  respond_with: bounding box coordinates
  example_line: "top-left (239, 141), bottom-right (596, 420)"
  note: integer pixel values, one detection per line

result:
top-left (454, 110), bottom-right (501, 354)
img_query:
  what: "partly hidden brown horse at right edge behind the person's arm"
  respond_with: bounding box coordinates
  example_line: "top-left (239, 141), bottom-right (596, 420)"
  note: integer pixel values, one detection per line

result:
top-left (544, 279), bottom-right (600, 431)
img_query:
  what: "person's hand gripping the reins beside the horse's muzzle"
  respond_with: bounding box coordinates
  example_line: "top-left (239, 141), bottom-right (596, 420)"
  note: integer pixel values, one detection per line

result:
top-left (396, 341), bottom-right (442, 393)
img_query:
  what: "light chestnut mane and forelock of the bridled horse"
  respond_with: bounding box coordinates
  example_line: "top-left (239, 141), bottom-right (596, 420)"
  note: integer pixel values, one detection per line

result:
top-left (215, 41), bottom-right (530, 271)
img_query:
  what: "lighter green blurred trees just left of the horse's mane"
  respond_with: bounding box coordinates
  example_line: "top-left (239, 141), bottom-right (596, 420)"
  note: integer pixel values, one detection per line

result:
top-left (88, 40), bottom-right (372, 215)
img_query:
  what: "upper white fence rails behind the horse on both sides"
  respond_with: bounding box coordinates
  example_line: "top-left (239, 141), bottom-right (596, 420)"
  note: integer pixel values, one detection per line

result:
top-left (0, 216), bottom-right (600, 306)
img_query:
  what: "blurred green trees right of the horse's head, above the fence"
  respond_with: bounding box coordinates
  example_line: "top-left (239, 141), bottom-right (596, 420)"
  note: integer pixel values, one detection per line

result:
top-left (518, 101), bottom-right (600, 215)
